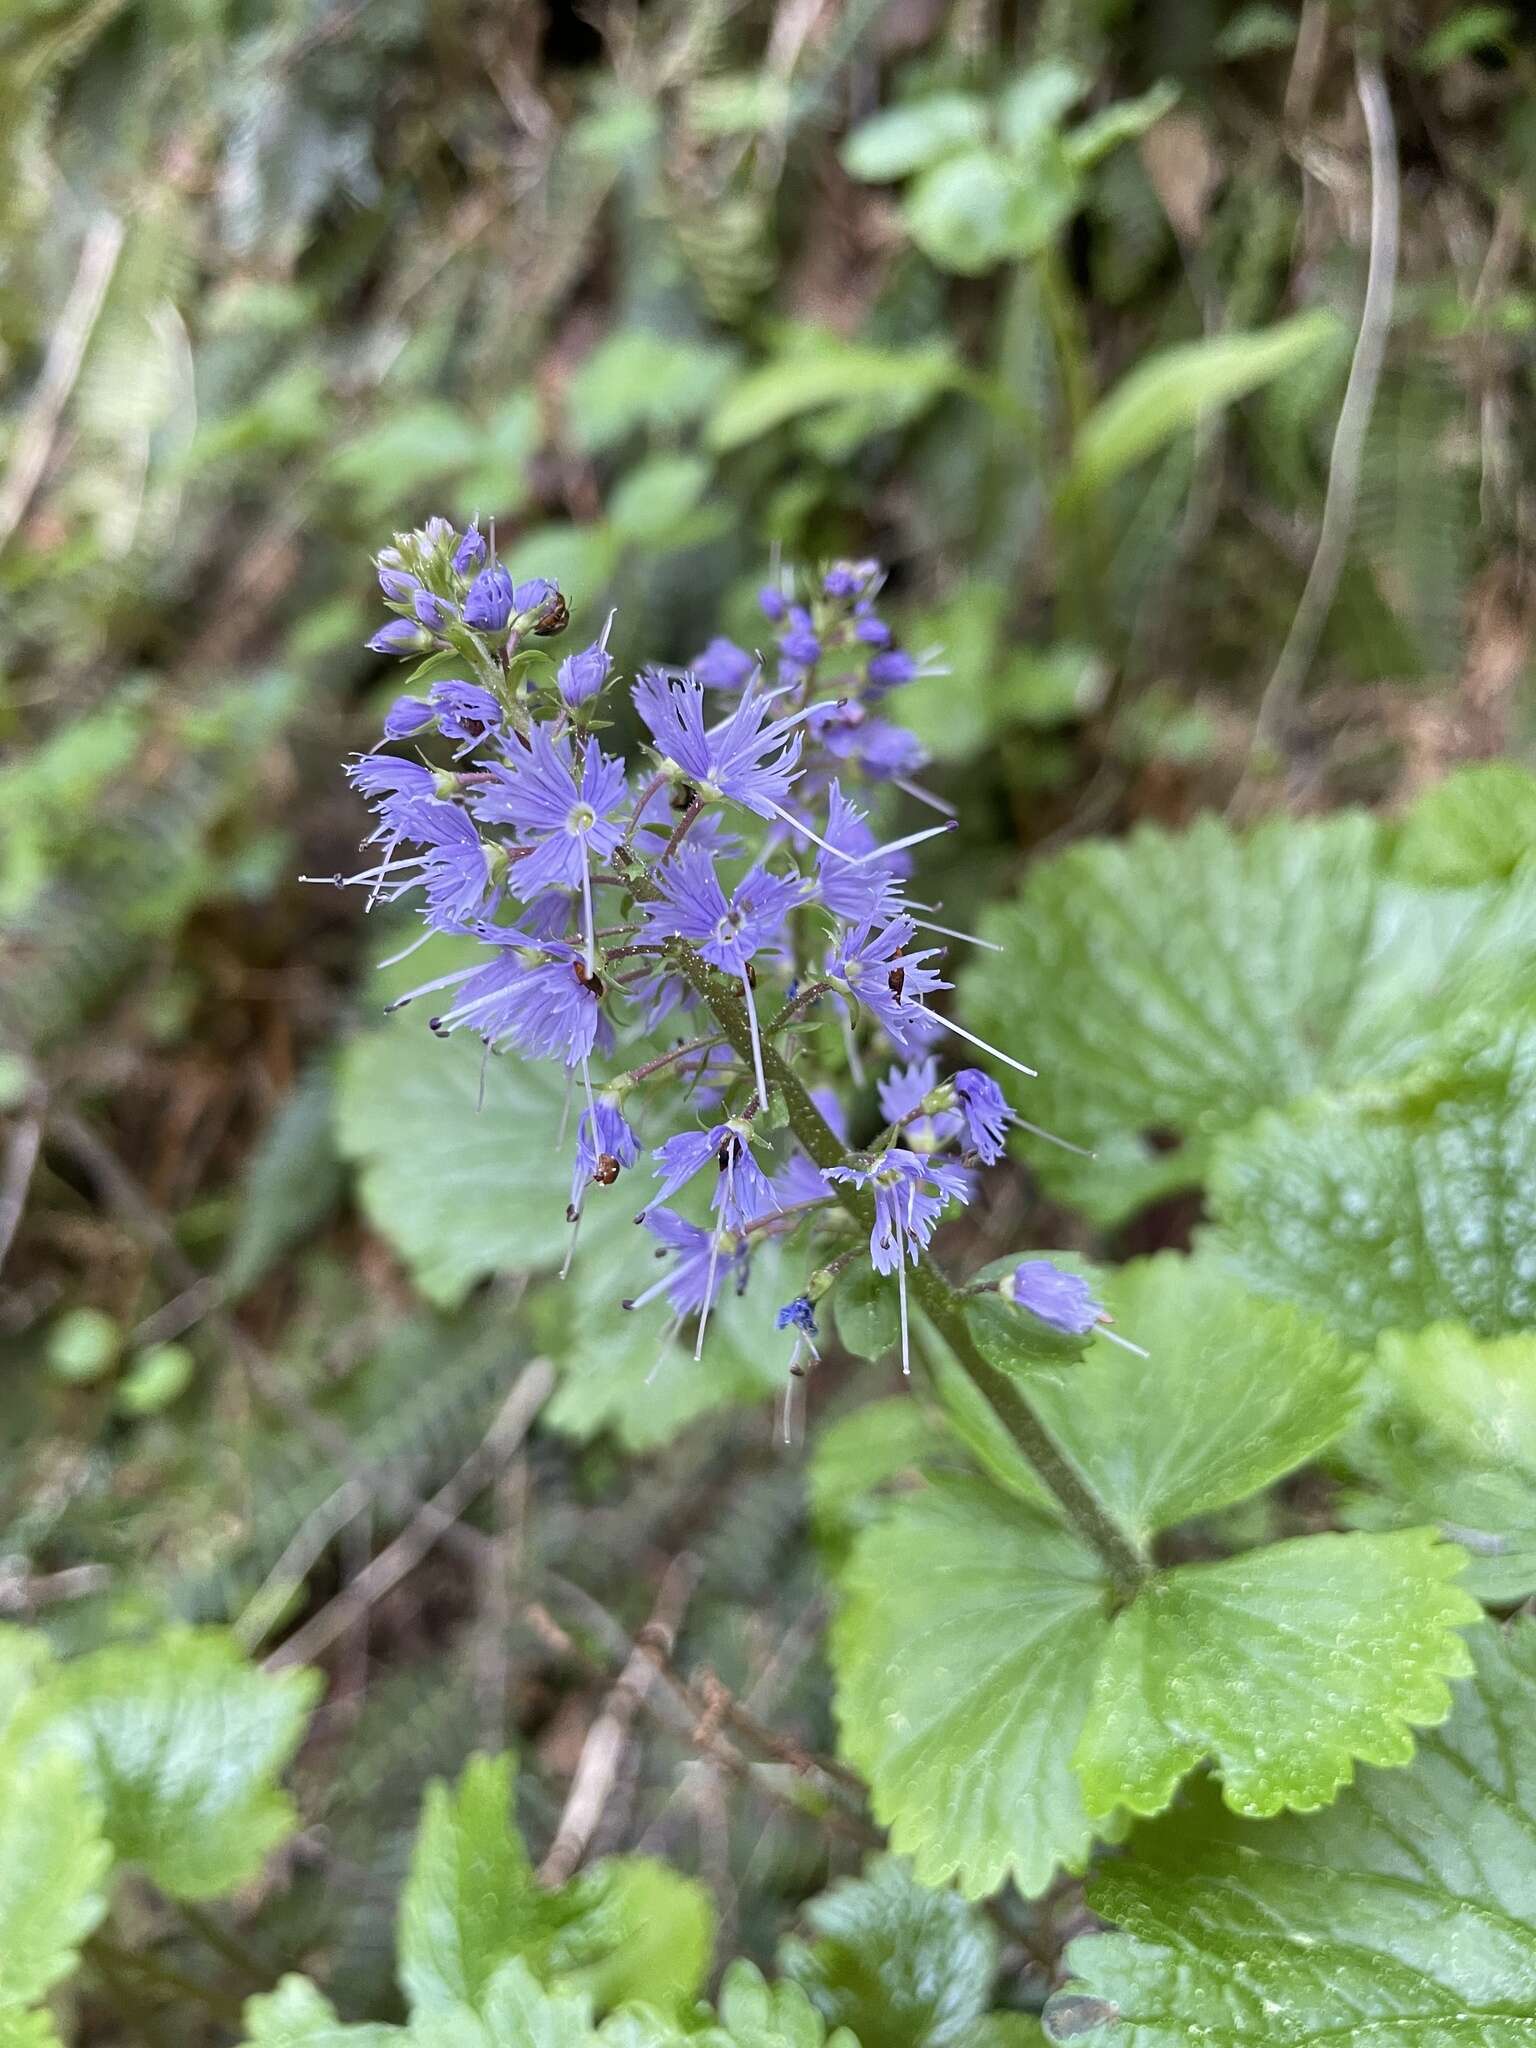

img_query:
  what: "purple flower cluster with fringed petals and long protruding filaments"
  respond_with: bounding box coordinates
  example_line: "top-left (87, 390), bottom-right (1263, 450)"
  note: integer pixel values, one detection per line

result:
top-left (330, 520), bottom-right (1122, 1370)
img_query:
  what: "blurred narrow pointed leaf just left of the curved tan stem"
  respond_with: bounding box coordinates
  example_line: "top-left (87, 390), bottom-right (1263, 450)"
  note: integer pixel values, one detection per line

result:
top-left (1063, 309), bottom-right (1335, 502)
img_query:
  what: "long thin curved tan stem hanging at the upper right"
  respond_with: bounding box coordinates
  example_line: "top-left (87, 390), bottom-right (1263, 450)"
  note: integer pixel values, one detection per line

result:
top-left (1249, 47), bottom-right (1399, 766)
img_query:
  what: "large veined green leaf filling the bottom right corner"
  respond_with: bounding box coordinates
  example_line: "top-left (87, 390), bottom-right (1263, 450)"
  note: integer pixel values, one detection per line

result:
top-left (1047, 1620), bottom-right (1536, 2048)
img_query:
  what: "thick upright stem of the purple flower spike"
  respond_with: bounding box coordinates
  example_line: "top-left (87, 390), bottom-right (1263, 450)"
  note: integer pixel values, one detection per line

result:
top-left (676, 946), bottom-right (1147, 1599)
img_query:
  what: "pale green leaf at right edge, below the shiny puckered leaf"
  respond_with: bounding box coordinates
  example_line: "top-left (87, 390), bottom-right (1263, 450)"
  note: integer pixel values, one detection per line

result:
top-left (1341, 1323), bottom-right (1536, 1606)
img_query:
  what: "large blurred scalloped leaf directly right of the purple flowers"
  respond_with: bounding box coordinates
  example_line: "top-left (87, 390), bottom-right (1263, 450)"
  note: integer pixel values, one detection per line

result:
top-left (961, 813), bottom-right (1536, 1223)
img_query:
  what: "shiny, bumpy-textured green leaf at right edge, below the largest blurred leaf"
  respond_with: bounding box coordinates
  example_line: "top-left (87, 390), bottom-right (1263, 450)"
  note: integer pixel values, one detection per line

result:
top-left (1210, 1026), bottom-right (1536, 1346)
